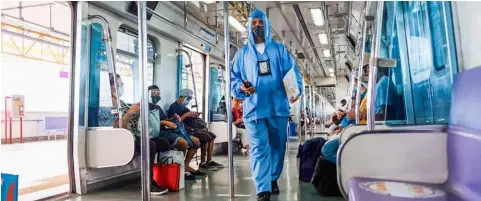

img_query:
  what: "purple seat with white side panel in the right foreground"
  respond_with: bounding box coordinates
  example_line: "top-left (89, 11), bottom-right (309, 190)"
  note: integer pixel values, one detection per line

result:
top-left (338, 67), bottom-right (481, 201)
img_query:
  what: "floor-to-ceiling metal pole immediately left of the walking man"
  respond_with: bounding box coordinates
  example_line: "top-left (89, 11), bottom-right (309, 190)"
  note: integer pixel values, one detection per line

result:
top-left (223, 1), bottom-right (234, 199)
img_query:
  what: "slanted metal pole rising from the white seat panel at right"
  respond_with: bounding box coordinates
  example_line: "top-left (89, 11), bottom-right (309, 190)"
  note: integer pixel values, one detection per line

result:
top-left (367, 1), bottom-right (384, 131)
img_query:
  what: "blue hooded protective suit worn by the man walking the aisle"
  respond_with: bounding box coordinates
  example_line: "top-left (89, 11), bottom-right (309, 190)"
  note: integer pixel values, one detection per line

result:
top-left (231, 9), bottom-right (303, 193)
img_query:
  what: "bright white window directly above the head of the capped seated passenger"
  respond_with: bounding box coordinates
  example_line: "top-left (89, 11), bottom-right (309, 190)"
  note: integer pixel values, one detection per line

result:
top-left (181, 47), bottom-right (205, 112)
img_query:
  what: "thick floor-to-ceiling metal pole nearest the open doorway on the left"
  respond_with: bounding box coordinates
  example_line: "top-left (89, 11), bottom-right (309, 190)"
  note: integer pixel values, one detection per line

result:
top-left (137, 1), bottom-right (152, 201)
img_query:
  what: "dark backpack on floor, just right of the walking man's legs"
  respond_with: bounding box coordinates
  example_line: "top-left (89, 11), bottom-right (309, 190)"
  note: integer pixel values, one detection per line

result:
top-left (297, 137), bottom-right (326, 182)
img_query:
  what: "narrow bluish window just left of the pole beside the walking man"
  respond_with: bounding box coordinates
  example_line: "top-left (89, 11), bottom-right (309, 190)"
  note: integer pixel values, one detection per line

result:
top-left (209, 66), bottom-right (227, 121)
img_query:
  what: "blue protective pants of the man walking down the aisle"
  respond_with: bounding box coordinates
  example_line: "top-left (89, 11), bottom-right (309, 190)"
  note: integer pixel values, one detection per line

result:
top-left (245, 117), bottom-right (288, 193)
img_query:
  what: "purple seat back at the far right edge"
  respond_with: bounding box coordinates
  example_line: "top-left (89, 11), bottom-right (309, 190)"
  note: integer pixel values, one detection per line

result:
top-left (448, 67), bottom-right (481, 200)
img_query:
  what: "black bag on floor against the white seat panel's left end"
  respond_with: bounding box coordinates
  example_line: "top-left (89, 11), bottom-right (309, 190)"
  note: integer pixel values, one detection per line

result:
top-left (311, 156), bottom-right (342, 196)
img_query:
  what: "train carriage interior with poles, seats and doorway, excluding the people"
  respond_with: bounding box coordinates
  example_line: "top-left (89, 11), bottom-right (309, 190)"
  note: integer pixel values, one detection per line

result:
top-left (0, 1), bottom-right (481, 201)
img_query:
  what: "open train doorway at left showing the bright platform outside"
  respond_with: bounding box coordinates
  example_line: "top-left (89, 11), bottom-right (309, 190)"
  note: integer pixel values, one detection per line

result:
top-left (0, 0), bottom-right (75, 200)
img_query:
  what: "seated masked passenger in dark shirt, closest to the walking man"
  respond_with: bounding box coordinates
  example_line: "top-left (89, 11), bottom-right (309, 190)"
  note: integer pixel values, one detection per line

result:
top-left (168, 89), bottom-right (224, 170)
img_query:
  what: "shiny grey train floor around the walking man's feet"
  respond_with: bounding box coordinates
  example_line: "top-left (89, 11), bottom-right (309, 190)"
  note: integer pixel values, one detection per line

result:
top-left (62, 134), bottom-right (344, 201)
